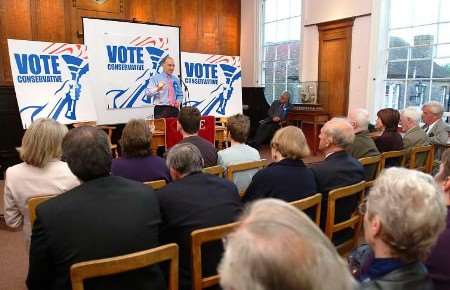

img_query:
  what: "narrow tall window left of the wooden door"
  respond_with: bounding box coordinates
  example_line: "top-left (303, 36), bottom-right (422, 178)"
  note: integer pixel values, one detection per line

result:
top-left (261, 0), bottom-right (302, 104)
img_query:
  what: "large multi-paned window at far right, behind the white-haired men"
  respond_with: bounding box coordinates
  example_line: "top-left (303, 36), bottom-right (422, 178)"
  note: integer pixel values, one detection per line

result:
top-left (384, 0), bottom-right (450, 111)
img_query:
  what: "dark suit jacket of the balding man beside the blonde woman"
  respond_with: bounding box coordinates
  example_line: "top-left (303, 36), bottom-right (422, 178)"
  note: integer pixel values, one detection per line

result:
top-left (311, 151), bottom-right (364, 243)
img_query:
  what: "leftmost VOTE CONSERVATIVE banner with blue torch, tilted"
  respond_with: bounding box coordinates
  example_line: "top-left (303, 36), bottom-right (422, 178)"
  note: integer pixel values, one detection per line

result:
top-left (8, 39), bottom-right (97, 128)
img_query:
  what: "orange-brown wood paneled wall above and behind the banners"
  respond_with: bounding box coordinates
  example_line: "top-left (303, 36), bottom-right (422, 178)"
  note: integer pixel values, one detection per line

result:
top-left (0, 0), bottom-right (241, 86)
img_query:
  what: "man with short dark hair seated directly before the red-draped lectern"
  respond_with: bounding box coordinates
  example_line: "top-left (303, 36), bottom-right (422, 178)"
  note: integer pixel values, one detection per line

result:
top-left (177, 107), bottom-right (217, 167)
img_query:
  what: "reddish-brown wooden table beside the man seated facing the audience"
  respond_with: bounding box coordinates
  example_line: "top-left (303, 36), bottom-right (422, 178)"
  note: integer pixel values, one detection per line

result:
top-left (288, 105), bottom-right (329, 155)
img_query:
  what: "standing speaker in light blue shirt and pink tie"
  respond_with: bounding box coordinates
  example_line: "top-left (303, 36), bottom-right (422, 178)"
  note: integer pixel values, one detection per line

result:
top-left (146, 56), bottom-right (183, 118)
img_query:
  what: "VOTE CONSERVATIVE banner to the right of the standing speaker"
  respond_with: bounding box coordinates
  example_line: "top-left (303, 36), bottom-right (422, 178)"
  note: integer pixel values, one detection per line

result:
top-left (181, 52), bottom-right (242, 117)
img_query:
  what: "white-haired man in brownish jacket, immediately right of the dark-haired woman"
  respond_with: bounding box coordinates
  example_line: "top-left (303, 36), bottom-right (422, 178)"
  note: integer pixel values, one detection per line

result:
top-left (400, 107), bottom-right (430, 164)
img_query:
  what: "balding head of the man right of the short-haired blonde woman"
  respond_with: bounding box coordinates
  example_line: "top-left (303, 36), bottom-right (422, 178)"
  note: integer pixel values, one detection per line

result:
top-left (319, 118), bottom-right (355, 151)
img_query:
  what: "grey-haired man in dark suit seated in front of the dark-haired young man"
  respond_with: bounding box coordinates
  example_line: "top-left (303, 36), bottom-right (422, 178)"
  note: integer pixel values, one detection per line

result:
top-left (157, 143), bottom-right (241, 290)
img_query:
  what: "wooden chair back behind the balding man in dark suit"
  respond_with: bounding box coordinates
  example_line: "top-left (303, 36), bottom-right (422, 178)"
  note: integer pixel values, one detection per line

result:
top-left (325, 181), bottom-right (366, 254)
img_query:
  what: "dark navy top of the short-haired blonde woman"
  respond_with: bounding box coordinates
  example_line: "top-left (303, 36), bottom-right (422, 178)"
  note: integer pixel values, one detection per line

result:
top-left (242, 159), bottom-right (318, 202)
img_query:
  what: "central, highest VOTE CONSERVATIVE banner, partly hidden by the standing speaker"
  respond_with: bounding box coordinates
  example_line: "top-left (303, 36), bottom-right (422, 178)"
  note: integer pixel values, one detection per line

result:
top-left (83, 18), bottom-right (180, 124)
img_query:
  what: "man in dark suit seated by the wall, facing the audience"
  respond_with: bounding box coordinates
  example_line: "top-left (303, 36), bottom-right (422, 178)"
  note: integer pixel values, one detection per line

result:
top-left (250, 91), bottom-right (292, 150)
